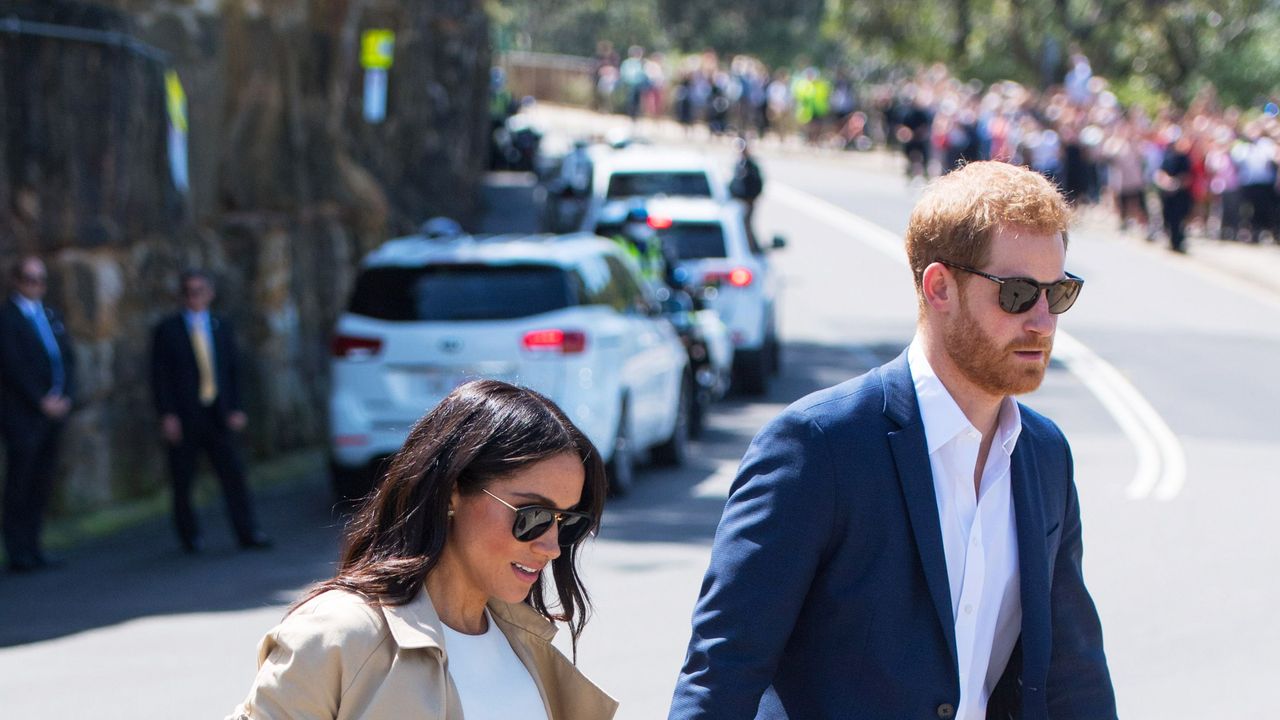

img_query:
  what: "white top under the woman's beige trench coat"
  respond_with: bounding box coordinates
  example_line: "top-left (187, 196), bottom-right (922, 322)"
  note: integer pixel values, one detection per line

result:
top-left (442, 610), bottom-right (547, 720)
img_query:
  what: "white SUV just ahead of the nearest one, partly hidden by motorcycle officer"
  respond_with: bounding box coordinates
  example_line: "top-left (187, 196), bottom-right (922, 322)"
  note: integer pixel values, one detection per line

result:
top-left (645, 197), bottom-right (786, 395)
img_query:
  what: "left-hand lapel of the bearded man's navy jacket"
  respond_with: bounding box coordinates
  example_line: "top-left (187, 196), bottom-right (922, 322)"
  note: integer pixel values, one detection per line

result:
top-left (881, 352), bottom-right (959, 667)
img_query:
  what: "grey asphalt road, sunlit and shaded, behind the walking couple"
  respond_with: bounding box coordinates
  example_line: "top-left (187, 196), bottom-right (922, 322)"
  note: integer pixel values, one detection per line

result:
top-left (0, 109), bottom-right (1280, 720)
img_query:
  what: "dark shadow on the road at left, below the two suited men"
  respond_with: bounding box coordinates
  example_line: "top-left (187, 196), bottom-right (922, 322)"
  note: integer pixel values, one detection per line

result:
top-left (0, 477), bottom-right (340, 650)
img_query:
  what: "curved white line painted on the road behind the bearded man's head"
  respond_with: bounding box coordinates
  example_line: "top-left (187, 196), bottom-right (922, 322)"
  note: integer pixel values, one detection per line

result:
top-left (757, 182), bottom-right (1187, 501)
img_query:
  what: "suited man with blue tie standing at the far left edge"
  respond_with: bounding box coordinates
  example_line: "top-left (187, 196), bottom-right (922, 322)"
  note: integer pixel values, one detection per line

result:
top-left (0, 256), bottom-right (76, 573)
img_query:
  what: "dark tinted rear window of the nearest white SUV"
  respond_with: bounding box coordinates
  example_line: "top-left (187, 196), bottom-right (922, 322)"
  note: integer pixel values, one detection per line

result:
top-left (349, 264), bottom-right (576, 320)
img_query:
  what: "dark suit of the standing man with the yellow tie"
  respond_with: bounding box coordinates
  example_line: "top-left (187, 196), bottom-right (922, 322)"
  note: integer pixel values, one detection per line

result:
top-left (151, 313), bottom-right (257, 550)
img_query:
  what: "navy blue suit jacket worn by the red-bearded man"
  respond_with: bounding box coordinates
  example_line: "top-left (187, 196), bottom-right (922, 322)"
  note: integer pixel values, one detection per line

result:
top-left (671, 354), bottom-right (1116, 720)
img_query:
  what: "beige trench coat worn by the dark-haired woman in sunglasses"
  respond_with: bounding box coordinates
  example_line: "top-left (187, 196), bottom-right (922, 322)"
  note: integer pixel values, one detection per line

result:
top-left (228, 591), bottom-right (618, 720)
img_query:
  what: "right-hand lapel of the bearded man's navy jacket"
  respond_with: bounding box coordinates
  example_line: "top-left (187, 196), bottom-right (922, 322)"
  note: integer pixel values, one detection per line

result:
top-left (1010, 435), bottom-right (1051, 679)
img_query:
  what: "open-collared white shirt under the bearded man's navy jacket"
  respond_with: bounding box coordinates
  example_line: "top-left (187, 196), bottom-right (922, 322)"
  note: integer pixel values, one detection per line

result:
top-left (906, 337), bottom-right (1023, 720)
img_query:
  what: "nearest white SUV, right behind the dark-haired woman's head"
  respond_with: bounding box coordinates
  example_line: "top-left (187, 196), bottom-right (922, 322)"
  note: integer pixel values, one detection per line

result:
top-left (329, 233), bottom-right (692, 497)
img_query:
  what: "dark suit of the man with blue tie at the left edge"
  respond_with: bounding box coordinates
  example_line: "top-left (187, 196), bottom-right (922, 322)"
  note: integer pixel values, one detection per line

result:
top-left (0, 299), bottom-right (76, 568)
